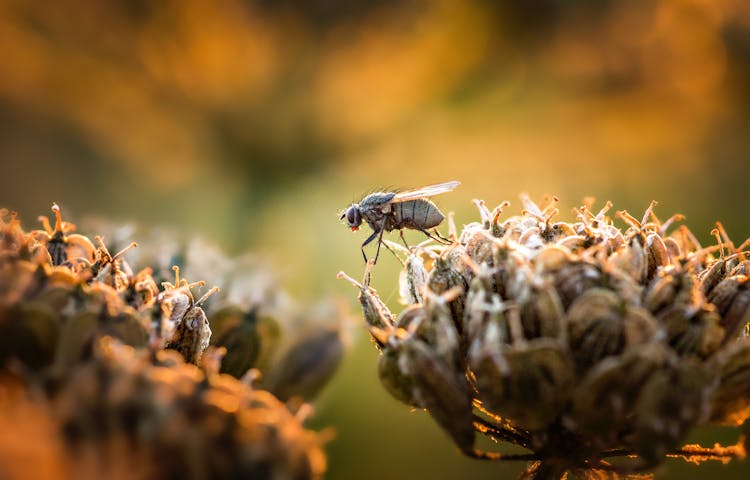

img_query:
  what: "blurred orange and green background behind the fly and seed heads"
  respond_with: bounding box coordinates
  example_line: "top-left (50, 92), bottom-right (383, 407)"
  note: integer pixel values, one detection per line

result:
top-left (0, 0), bottom-right (750, 479)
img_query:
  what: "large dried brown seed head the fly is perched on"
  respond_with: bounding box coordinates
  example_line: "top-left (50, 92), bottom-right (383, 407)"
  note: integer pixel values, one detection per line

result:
top-left (340, 197), bottom-right (750, 478)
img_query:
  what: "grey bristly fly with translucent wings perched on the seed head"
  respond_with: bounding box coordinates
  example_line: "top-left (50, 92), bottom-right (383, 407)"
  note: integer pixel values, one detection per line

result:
top-left (340, 180), bottom-right (460, 263)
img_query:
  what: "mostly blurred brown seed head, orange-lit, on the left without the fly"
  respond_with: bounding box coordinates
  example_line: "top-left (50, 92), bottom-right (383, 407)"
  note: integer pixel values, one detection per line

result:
top-left (0, 205), bottom-right (343, 478)
